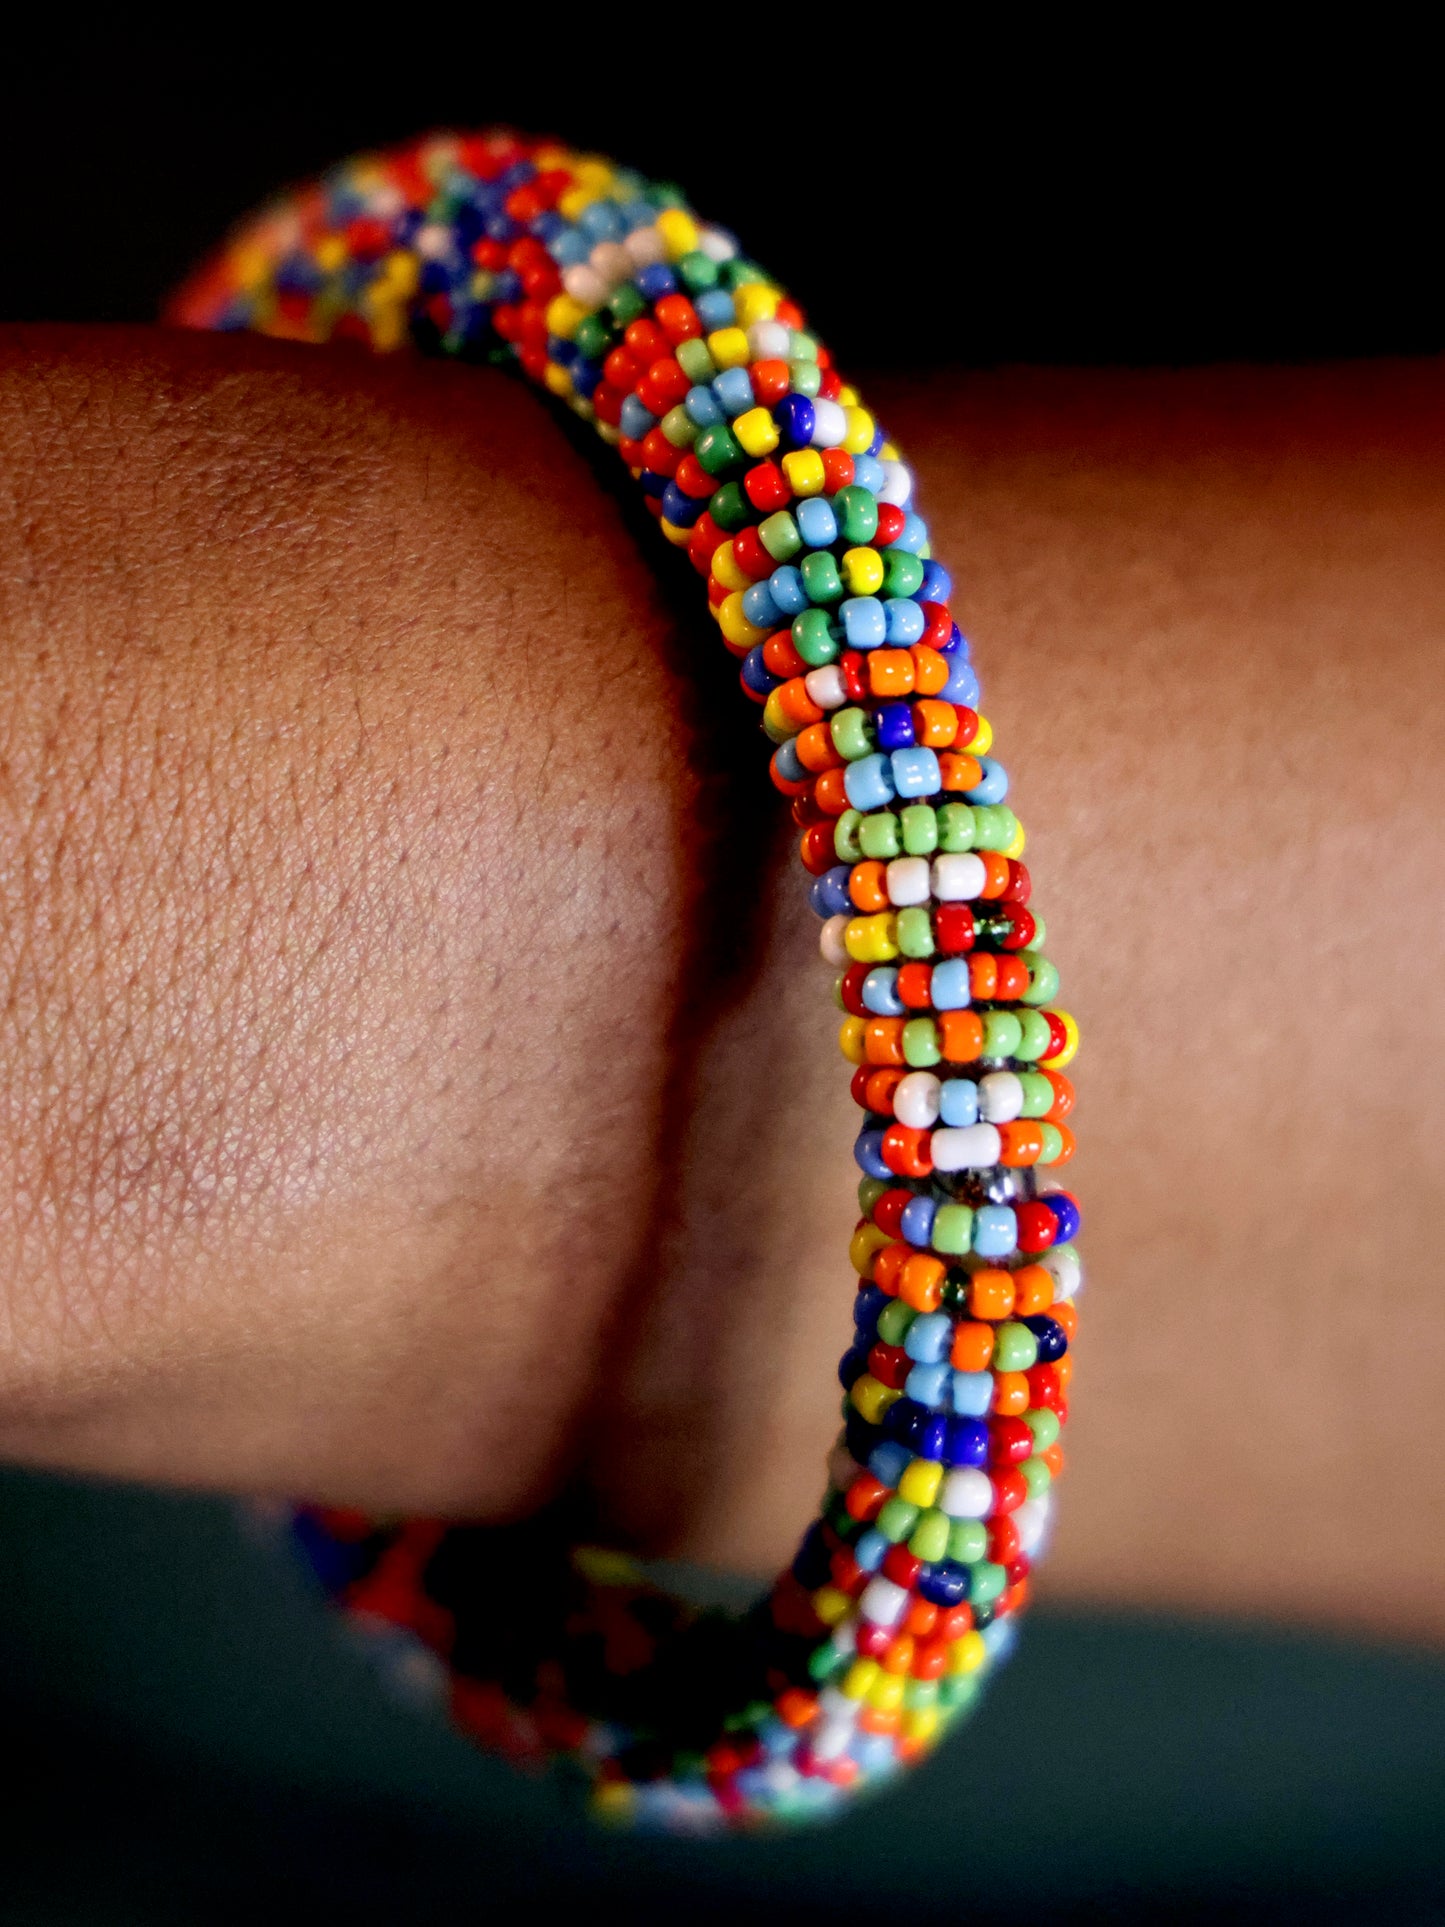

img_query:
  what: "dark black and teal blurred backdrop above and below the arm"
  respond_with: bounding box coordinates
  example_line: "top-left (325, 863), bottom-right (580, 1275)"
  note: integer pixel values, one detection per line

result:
top-left (0, 30), bottom-right (1445, 1927)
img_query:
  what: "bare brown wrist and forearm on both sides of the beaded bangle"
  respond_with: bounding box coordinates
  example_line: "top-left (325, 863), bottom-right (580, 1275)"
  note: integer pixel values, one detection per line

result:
top-left (0, 331), bottom-right (1445, 1636)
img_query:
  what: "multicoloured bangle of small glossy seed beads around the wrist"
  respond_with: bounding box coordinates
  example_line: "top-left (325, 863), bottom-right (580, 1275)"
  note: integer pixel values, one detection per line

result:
top-left (171, 133), bottom-right (1079, 1829)
